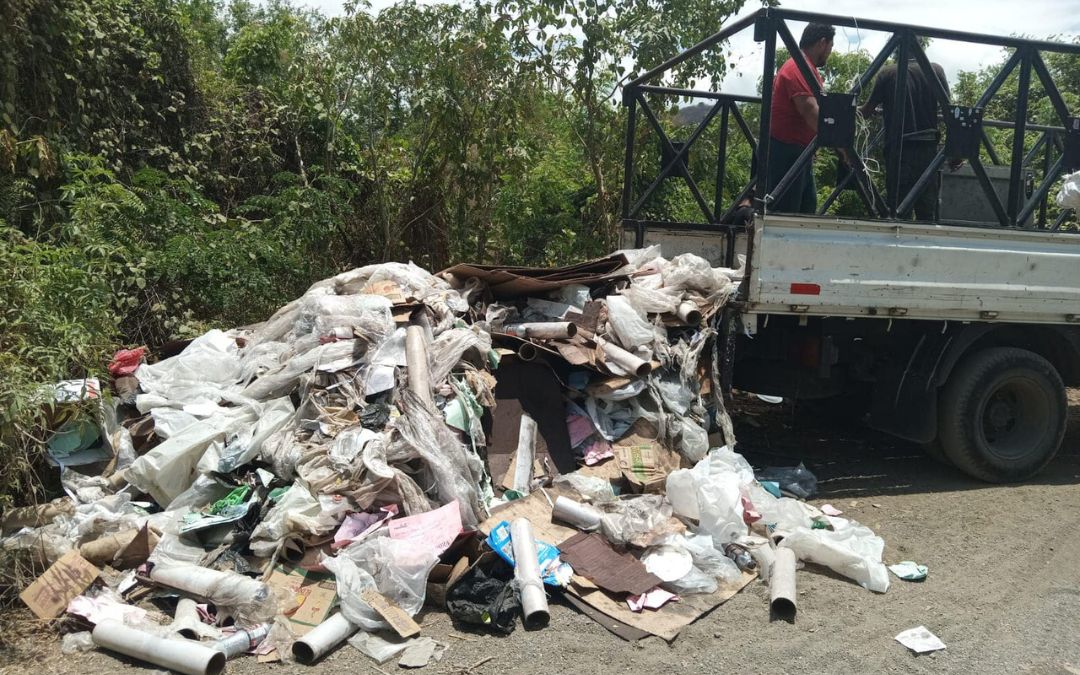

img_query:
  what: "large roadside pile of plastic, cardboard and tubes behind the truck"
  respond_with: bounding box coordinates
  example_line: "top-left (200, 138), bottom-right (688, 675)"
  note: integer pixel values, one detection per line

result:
top-left (0, 247), bottom-right (889, 674)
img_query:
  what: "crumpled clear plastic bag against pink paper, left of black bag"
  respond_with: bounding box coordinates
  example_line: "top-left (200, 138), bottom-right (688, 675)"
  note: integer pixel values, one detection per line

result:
top-left (322, 536), bottom-right (438, 631)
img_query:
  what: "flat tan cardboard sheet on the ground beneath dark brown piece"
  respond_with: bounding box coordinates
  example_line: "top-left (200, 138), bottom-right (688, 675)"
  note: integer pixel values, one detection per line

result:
top-left (567, 572), bottom-right (757, 642)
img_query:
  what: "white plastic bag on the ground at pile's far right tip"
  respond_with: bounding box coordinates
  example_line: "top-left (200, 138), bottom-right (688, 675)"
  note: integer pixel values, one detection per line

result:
top-left (780, 518), bottom-right (889, 593)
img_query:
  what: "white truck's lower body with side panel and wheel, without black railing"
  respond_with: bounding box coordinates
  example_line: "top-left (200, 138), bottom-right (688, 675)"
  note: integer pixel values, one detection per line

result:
top-left (627, 215), bottom-right (1080, 482)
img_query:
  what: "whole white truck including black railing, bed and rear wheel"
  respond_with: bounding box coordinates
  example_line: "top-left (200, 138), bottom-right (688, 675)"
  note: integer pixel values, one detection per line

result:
top-left (622, 9), bottom-right (1080, 482)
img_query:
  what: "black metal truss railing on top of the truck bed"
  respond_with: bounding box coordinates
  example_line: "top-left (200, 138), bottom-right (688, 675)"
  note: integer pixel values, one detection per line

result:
top-left (622, 9), bottom-right (1080, 245)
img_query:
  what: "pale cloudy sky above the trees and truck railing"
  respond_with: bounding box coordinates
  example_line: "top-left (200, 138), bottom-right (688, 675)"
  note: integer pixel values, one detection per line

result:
top-left (299, 0), bottom-right (1080, 94)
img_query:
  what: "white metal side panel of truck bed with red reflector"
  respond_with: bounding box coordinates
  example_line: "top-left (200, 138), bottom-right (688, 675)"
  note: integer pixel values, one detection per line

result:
top-left (747, 215), bottom-right (1080, 324)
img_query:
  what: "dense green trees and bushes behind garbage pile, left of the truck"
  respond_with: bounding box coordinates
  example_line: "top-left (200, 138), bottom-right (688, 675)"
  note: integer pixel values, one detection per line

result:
top-left (0, 0), bottom-right (742, 505)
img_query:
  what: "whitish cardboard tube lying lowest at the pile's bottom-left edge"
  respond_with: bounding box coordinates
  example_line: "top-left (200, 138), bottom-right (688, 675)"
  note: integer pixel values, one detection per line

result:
top-left (92, 619), bottom-right (225, 675)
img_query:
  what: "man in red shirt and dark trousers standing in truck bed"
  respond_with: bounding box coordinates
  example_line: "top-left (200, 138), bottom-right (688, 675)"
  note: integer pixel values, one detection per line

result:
top-left (768, 24), bottom-right (836, 214)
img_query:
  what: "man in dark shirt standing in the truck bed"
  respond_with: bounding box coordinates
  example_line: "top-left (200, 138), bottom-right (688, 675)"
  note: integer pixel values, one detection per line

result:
top-left (859, 58), bottom-right (948, 220)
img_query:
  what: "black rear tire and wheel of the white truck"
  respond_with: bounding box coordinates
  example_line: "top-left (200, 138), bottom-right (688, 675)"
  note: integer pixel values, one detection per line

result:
top-left (937, 347), bottom-right (1068, 483)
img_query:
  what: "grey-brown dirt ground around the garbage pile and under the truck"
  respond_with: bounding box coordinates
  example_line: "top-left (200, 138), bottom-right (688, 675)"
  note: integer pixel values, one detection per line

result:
top-left (0, 390), bottom-right (1080, 675)
